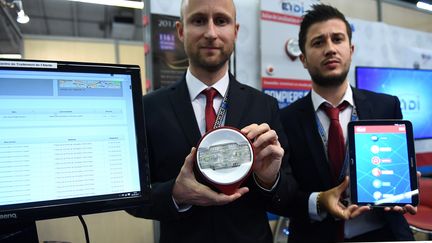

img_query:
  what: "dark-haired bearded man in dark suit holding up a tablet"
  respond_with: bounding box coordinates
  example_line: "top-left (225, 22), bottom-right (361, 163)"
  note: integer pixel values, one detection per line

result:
top-left (274, 4), bottom-right (416, 243)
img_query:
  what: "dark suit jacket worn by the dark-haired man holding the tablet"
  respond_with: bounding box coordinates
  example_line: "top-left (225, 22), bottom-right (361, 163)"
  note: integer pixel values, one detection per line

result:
top-left (274, 88), bottom-right (412, 243)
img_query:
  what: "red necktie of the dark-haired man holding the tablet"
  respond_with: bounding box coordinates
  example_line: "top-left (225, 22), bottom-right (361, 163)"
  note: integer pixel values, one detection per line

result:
top-left (321, 101), bottom-right (349, 242)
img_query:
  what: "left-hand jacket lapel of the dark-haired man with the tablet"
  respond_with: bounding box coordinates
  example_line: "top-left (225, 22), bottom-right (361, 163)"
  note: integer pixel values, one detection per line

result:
top-left (298, 92), bottom-right (332, 187)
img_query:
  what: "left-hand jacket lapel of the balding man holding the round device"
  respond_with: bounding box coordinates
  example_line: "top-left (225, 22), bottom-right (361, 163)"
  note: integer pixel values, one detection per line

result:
top-left (170, 77), bottom-right (201, 146)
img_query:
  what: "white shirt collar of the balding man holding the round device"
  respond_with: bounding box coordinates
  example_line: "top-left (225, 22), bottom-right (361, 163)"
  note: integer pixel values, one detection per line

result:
top-left (186, 68), bottom-right (229, 100)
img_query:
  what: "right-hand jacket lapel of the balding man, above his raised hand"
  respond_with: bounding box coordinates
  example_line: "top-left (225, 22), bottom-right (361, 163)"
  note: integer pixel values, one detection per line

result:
top-left (225, 74), bottom-right (249, 127)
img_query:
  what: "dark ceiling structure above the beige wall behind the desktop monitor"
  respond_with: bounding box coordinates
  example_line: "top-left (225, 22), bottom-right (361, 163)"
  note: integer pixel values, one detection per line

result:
top-left (0, 0), bottom-right (143, 54)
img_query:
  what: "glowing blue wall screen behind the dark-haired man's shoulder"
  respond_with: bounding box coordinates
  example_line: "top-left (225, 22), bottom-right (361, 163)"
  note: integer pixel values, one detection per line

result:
top-left (355, 67), bottom-right (432, 139)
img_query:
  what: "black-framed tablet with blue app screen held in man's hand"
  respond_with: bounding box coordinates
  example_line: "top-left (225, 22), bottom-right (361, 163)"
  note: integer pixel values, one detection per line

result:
top-left (348, 120), bottom-right (418, 207)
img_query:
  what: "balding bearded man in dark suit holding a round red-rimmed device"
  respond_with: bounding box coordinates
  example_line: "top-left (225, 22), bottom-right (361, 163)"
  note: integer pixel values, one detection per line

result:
top-left (129, 0), bottom-right (294, 243)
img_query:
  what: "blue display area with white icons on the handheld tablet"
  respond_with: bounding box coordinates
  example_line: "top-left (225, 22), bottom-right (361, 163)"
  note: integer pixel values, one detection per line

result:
top-left (355, 127), bottom-right (411, 203)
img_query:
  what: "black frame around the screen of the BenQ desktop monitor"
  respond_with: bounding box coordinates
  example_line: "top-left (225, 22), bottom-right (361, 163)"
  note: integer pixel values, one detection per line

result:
top-left (0, 59), bottom-right (151, 224)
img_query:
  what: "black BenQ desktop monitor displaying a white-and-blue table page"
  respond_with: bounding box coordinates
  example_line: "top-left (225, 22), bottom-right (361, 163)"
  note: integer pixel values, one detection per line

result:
top-left (0, 59), bottom-right (150, 223)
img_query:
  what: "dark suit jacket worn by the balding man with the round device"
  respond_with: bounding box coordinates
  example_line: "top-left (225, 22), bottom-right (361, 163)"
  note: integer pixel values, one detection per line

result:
top-left (129, 76), bottom-right (296, 243)
